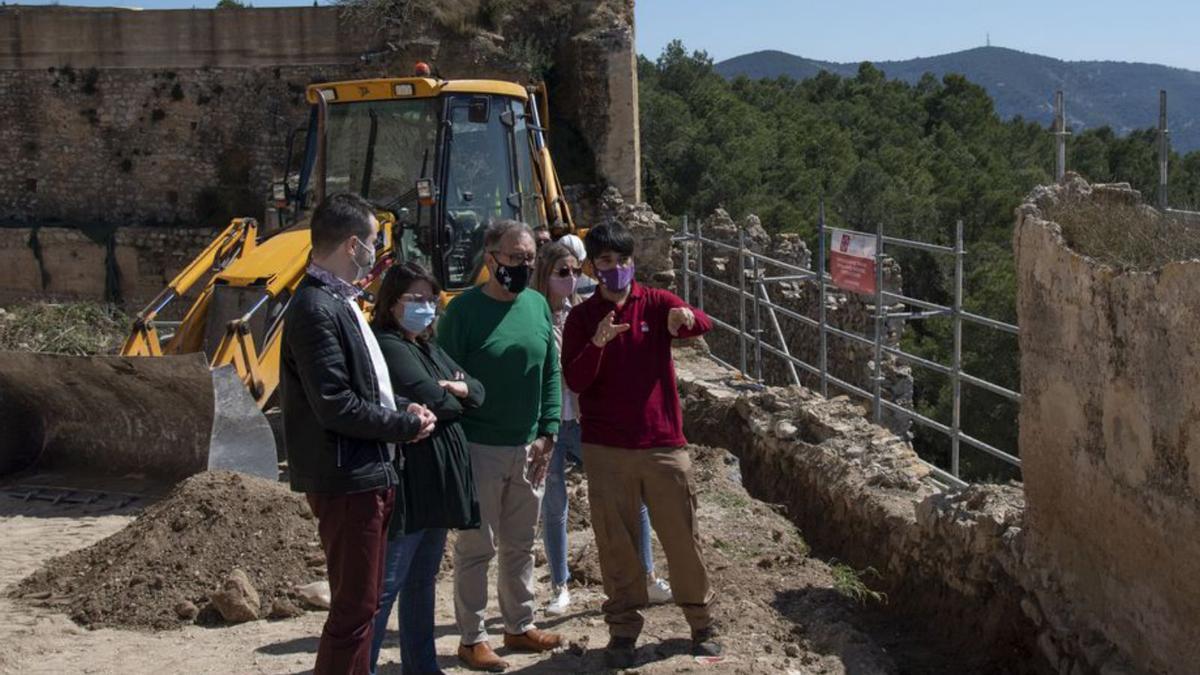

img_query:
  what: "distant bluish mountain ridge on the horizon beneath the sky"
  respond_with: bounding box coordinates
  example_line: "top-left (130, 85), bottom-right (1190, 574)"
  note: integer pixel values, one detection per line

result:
top-left (714, 47), bottom-right (1200, 153)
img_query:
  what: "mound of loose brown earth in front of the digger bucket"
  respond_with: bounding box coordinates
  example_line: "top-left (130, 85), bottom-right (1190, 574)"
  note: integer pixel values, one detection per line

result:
top-left (11, 471), bottom-right (325, 629)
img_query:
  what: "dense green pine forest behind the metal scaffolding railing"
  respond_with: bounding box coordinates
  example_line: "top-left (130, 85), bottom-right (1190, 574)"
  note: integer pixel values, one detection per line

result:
top-left (638, 42), bottom-right (1200, 477)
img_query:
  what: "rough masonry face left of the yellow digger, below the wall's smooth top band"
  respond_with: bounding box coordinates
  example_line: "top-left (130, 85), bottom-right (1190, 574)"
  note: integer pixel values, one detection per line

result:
top-left (0, 66), bottom-right (355, 227)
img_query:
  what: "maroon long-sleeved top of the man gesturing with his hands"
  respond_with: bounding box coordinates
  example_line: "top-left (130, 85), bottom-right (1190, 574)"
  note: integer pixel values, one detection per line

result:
top-left (563, 282), bottom-right (713, 449)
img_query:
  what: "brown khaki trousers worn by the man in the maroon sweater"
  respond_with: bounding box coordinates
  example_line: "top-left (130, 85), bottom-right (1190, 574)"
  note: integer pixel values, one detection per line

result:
top-left (583, 443), bottom-right (713, 638)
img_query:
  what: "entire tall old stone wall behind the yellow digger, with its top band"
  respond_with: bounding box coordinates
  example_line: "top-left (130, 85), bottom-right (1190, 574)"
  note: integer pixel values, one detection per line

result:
top-left (0, 0), bottom-right (640, 225)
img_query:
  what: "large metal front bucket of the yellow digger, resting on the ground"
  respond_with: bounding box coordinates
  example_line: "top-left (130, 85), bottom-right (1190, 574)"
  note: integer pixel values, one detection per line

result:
top-left (0, 352), bottom-right (278, 482)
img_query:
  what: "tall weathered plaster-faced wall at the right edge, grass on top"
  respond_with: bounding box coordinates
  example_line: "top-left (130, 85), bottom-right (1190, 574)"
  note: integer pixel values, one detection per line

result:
top-left (1014, 179), bottom-right (1200, 673)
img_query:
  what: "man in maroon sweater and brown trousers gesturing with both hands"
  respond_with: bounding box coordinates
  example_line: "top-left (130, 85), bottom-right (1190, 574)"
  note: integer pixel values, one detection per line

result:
top-left (563, 225), bottom-right (721, 668)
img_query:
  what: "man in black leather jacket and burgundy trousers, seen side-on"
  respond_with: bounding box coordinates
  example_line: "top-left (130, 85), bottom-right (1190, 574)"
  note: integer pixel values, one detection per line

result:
top-left (280, 195), bottom-right (436, 675)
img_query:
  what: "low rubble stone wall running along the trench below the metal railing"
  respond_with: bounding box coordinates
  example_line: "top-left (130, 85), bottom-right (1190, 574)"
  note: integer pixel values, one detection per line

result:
top-left (676, 351), bottom-right (1041, 673)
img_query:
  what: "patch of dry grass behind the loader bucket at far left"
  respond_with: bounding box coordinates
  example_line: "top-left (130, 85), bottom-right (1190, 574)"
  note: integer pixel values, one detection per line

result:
top-left (0, 297), bottom-right (130, 356)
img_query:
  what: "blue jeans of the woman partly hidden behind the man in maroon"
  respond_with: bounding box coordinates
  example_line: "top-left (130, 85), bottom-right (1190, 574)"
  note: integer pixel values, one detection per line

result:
top-left (541, 420), bottom-right (654, 586)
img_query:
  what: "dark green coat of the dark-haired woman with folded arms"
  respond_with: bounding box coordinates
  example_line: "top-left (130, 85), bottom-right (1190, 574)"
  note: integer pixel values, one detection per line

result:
top-left (377, 331), bottom-right (484, 536)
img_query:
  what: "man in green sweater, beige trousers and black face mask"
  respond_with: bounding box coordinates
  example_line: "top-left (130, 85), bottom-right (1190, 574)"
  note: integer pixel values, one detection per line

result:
top-left (438, 220), bottom-right (562, 671)
